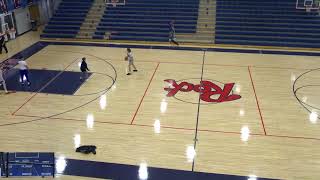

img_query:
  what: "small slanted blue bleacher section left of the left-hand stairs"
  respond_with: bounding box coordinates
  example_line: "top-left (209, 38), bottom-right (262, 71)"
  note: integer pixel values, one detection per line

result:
top-left (41, 0), bottom-right (93, 38)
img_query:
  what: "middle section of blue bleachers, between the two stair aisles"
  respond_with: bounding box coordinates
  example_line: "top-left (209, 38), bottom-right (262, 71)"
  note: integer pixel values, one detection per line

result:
top-left (93, 0), bottom-right (199, 41)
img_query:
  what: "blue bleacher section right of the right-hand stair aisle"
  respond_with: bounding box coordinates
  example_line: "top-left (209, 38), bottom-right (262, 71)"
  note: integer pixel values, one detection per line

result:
top-left (215, 0), bottom-right (320, 48)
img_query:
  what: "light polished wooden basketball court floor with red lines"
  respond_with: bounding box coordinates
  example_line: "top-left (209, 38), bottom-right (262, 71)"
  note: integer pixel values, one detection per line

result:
top-left (0, 33), bottom-right (320, 180)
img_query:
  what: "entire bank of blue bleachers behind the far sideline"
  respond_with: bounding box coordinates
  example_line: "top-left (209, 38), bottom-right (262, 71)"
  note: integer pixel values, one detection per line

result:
top-left (41, 0), bottom-right (320, 48)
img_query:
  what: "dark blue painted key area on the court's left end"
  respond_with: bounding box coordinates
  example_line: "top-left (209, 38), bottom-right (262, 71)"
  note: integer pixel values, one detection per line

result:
top-left (1, 69), bottom-right (92, 95)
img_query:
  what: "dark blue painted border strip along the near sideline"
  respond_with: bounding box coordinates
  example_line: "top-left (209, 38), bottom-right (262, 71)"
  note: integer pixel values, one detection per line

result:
top-left (63, 159), bottom-right (272, 180)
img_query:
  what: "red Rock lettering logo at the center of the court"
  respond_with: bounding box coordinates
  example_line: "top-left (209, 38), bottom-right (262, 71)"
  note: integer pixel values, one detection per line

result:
top-left (164, 79), bottom-right (241, 104)
